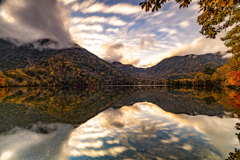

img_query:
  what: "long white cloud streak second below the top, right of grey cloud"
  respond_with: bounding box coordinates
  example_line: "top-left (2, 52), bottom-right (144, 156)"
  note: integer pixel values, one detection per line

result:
top-left (71, 16), bottom-right (127, 26)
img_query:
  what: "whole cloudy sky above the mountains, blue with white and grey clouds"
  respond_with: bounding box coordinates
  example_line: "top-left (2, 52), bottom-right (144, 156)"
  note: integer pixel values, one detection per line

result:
top-left (0, 0), bottom-right (227, 67)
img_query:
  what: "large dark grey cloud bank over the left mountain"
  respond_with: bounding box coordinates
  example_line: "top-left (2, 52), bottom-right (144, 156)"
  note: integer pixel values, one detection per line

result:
top-left (0, 0), bottom-right (73, 48)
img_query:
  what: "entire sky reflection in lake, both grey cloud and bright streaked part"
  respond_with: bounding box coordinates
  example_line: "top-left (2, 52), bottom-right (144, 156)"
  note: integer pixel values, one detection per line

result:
top-left (0, 102), bottom-right (239, 160)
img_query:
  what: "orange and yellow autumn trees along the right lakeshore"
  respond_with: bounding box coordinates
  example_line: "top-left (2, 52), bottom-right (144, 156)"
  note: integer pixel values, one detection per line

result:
top-left (166, 58), bottom-right (240, 90)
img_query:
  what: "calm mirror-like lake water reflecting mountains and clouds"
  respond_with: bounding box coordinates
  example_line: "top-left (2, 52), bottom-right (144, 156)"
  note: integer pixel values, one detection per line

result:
top-left (0, 86), bottom-right (240, 160)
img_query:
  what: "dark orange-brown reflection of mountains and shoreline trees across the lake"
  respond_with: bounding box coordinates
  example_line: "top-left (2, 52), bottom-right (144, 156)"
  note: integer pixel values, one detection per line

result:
top-left (0, 86), bottom-right (240, 132)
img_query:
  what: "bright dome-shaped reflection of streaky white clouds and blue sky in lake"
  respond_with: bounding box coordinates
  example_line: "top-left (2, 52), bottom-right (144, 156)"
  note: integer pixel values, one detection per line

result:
top-left (64, 102), bottom-right (238, 159)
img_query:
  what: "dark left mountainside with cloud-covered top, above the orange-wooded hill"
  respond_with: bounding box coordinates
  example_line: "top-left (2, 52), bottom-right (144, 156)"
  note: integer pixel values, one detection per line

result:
top-left (0, 39), bottom-right (135, 84)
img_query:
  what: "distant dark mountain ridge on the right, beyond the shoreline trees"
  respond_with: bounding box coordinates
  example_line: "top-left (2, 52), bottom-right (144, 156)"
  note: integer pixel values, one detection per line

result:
top-left (113, 53), bottom-right (227, 79)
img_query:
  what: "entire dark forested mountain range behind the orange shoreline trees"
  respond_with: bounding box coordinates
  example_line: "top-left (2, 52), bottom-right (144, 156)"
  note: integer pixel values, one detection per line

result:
top-left (0, 38), bottom-right (227, 84)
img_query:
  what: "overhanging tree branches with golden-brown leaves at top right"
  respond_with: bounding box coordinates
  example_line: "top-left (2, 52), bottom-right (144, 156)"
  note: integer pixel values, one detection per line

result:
top-left (139, 0), bottom-right (240, 58)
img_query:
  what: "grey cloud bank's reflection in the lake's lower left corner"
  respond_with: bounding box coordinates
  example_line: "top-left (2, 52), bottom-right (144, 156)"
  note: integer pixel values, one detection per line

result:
top-left (0, 123), bottom-right (74, 160)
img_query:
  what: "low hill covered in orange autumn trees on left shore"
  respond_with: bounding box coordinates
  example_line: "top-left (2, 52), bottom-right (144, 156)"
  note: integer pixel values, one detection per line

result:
top-left (0, 56), bottom-right (97, 87)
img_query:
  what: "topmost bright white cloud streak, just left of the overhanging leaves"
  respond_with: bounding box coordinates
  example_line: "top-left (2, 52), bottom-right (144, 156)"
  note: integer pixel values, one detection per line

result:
top-left (80, 2), bottom-right (142, 15)
